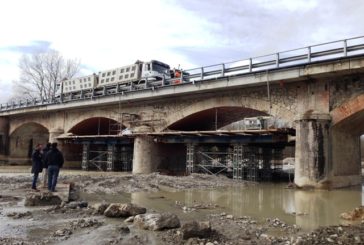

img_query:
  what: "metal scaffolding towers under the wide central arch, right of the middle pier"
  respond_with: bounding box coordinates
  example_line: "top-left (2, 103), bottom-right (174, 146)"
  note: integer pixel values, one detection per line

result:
top-left (186, 143), bottom-right (283, 181)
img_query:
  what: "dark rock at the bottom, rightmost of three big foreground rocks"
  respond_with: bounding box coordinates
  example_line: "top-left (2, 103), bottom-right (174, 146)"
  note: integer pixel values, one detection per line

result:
top-left (181, 221), bottom-right (212, 240)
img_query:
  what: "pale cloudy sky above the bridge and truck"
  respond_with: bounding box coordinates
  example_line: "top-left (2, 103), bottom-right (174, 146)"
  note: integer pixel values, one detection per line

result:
top-left (0, 0), bottom-right (364, 103)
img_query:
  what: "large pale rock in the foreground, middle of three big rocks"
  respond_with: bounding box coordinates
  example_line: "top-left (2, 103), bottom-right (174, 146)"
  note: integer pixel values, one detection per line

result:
top-left (134, 213), bottom-right (181, 231)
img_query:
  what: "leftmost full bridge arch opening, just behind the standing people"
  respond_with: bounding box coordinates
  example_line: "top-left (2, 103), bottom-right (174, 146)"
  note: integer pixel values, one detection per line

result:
top-left (9, 122), bottom-right (49, 158)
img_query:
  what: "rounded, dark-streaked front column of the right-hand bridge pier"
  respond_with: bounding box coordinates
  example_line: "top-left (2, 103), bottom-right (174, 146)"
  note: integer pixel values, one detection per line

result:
top-left (295, 112), bottom-right (331, 188)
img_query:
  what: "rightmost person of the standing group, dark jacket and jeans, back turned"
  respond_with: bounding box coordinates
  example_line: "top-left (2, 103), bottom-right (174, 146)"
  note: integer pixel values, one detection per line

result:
top-left (45, 143), bottom-right (64, 192)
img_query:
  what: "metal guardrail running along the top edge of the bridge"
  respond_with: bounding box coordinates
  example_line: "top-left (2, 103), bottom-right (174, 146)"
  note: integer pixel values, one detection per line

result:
top-left (0, 36), bottom-right (364, 111)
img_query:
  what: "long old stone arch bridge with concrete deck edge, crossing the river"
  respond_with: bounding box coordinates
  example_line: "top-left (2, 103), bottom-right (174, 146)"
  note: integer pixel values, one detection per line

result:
top-left (0, 41), bottom-right (364, 188)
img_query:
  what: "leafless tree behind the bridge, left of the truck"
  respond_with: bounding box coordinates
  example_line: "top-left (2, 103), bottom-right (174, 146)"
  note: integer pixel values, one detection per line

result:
top-left (12, 50), bottom-right (80, 101)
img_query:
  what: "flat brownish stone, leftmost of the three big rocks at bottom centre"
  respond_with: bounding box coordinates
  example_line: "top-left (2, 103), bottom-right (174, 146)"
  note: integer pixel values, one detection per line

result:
top-left (104, 203), bottom-right (147, 218)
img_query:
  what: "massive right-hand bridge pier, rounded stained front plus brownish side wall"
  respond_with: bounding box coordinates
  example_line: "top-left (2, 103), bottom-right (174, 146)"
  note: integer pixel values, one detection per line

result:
top-left (295, 113), bottom-right (361, 188)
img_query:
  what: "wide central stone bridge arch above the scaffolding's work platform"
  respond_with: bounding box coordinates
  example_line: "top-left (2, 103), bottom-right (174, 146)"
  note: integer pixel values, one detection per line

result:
top-left (162, 97), bottom-right (295, 130)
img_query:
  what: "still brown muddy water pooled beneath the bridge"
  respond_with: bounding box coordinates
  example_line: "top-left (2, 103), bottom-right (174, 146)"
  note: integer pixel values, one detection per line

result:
top-left (82, 184), bottom-right (364, 231)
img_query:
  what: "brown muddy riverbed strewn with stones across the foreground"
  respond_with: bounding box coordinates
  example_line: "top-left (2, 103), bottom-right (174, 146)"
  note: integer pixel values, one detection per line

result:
top-left (0, 171), bottom-right (364, 245)
